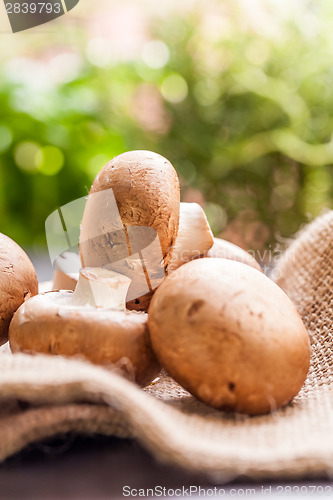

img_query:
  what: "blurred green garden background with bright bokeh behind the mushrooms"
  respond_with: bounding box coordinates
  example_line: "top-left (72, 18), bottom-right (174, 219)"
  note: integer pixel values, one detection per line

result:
top-left (0, 0), bottom-right (333, 276)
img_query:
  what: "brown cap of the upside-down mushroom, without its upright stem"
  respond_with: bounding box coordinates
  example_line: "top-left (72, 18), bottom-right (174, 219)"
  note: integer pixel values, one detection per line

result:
top-left (9, 291), bottom-right (160, 386)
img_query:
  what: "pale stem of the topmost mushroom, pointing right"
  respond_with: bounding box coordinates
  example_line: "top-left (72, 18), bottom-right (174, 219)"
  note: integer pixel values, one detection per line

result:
top-left (169, 203), bottom-right (214, 271)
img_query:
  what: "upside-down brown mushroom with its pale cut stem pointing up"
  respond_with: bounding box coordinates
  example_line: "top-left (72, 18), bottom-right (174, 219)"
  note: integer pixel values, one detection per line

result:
top-left (9, 268), bottom-right (159, 386)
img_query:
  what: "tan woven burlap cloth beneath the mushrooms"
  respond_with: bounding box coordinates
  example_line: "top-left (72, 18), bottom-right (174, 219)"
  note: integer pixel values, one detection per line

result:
top-left (0, 212), bottom-right (333, 480)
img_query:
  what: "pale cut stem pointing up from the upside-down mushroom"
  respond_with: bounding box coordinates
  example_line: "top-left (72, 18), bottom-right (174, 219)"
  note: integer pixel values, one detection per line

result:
top-left (71, 267), bottom-right (131, 311)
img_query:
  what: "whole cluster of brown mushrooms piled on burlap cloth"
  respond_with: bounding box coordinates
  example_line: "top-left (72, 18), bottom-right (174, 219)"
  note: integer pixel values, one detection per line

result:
top-left (0, 151), bottom-right (310, 415)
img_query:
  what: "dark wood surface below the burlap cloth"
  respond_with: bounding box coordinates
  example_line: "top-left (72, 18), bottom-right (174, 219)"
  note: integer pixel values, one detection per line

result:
top-left (0, 436), bottom-right (333, 500)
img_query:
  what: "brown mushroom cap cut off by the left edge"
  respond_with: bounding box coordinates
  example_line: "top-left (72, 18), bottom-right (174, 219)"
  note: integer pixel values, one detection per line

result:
top-left (0, 233), bottom-right (38, 345)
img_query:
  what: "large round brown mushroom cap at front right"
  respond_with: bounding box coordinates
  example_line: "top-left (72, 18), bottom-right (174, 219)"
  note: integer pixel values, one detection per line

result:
top-left (148, 259), bottom-right (310, 415)
